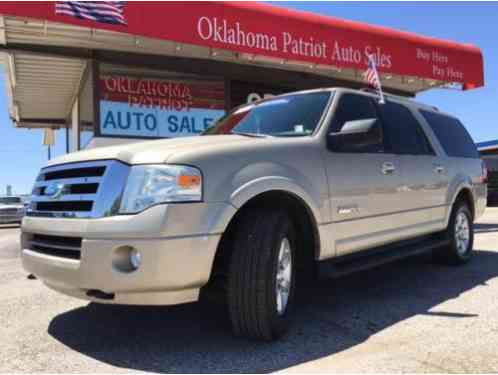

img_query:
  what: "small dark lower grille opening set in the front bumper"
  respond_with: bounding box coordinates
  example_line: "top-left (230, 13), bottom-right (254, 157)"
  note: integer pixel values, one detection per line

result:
top-left (23, 234), bottom-right (82, 260)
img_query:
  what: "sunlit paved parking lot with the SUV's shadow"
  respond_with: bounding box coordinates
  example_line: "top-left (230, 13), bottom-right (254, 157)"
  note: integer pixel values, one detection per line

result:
top-left (0, 208), bottom-right (498, 372)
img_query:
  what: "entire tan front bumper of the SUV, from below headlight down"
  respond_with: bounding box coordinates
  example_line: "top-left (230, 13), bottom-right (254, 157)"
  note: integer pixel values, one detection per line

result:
top-left (22, 203), bottom-right (235, 305)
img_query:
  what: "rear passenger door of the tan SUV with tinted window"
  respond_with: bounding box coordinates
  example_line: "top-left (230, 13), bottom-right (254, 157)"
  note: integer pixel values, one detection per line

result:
top-left (378, 100), bottom-right (447, 238)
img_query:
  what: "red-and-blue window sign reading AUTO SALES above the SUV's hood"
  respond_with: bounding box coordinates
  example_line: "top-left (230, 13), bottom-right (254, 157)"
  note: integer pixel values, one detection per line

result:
top-left (100, 75), bottom-right (225, 138)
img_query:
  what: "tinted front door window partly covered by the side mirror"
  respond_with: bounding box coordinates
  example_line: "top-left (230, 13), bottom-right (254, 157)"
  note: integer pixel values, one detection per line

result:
top-left (328, 94), bottom-right (384, 153)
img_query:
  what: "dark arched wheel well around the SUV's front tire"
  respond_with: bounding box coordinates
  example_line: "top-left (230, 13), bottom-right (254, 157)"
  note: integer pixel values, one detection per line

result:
top-left (208, 190), bottom-right (320, 286)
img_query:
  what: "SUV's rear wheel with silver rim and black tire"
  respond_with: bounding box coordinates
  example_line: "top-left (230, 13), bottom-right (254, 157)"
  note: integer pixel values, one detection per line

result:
top-left (434, 201), bottom-right (474, 265)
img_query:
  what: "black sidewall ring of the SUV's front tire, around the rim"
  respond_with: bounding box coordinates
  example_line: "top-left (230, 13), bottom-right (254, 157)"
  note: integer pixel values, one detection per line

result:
top-left (266, 215), bottom-right (297, 337)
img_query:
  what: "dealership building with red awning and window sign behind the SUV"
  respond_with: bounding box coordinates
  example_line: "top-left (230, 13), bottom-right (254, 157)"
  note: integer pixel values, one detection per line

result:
top-left (0, 2), bottom-right (484, 152)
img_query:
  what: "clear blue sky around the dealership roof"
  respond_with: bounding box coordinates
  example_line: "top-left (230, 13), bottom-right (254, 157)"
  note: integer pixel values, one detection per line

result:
top-left (0, 2), bottom-right (498, 194)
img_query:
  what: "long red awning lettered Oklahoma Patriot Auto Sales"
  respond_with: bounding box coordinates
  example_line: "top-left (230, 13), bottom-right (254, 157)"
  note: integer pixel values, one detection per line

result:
top-left (0, 1), bottom-right (484, 89)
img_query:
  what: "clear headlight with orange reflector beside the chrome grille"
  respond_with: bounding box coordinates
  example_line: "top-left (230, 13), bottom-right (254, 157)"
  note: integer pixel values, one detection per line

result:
top-left (119, 165), bottom-right (202, 213)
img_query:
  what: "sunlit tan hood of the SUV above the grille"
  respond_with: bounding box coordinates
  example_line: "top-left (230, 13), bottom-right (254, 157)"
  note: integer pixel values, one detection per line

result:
top-left (47, 135), bottom-right (258, 166)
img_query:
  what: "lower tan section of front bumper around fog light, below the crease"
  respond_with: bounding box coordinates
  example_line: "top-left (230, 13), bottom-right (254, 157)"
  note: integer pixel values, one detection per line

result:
top-left (22, 235), bottom-right (220, 305)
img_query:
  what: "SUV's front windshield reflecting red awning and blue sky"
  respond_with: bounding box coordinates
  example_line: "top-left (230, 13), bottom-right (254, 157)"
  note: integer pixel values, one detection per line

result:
top-left (203, 91), bottom-right (332, 137)
